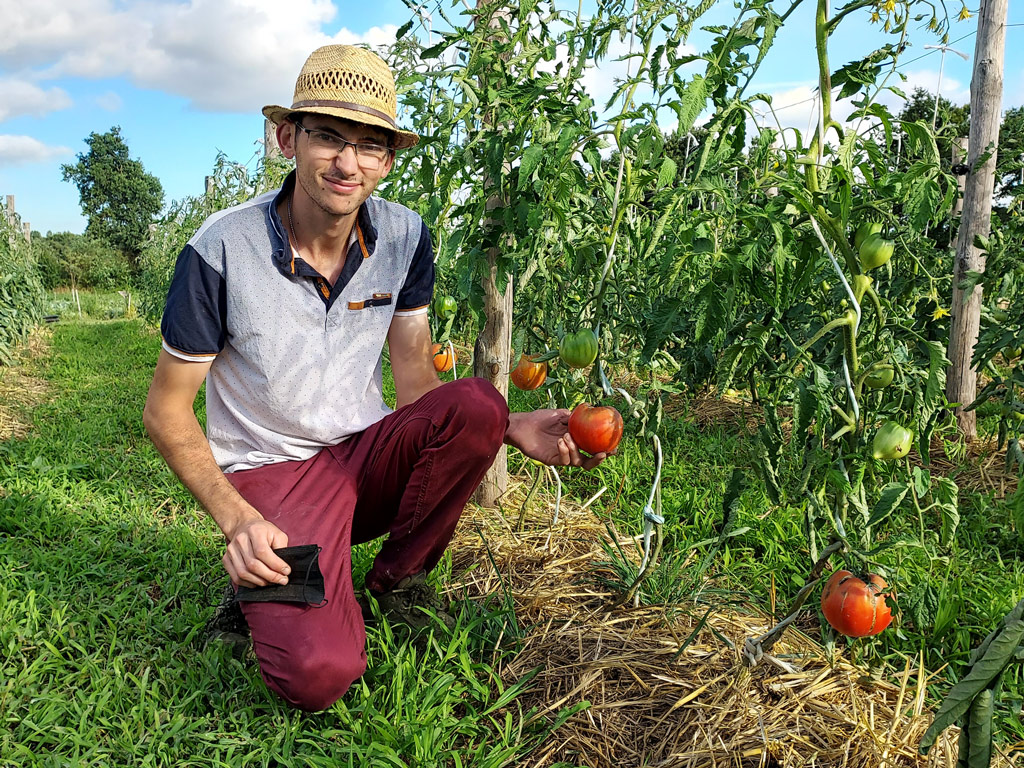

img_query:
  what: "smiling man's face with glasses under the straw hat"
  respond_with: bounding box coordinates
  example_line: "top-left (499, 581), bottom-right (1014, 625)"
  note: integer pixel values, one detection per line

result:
top-left (281, 115), bottom-right (394, 221)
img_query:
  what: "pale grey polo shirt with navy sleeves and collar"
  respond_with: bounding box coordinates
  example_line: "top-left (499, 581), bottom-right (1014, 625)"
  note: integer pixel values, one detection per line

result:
top-left (160, 171), bottom-right (434, 472)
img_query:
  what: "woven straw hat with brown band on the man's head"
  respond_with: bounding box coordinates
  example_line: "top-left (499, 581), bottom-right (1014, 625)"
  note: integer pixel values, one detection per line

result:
top-left (263, 45), bottom-right (420, 150)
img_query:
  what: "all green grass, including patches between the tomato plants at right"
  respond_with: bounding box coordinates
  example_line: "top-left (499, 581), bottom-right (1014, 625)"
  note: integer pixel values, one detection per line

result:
top-left (0, 305), bottom-right (1024, 768)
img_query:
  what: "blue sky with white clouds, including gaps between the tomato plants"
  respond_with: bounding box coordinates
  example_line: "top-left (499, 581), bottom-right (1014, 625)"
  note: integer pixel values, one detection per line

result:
top-left (0, 0), bottom-right (1024, 234)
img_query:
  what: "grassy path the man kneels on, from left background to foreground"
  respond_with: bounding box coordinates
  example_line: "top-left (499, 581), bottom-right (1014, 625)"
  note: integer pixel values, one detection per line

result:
top-left (0, 321), bottom-right (561, 768)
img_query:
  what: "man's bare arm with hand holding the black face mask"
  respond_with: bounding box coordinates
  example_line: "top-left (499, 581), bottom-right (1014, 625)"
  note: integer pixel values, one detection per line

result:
top-left (142, 349), bottom-right (289, 587)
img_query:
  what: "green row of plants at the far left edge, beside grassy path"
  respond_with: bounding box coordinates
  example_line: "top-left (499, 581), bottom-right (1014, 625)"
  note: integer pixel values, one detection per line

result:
top-left (0, 204), bottom-right (43, 365)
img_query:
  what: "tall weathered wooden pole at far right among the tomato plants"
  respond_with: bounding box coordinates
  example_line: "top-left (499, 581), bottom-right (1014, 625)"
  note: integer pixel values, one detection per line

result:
top-left (946, 0), bottom-right (1009, 441)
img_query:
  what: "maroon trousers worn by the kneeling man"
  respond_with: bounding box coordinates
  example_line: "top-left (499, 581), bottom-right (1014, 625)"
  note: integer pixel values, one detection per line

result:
top-left (227, 379), bottom-right (509, 712)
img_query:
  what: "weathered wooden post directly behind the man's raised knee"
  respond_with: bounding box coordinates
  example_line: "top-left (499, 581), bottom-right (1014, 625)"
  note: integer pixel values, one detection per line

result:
top-left (473, 0), bottom-right (513, 507)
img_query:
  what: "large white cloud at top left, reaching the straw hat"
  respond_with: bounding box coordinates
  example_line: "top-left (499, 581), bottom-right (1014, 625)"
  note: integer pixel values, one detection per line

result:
top-left (0, 0), bottom-right (397, 112)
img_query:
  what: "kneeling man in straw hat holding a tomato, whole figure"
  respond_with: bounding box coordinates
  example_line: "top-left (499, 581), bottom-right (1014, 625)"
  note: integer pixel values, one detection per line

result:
top-left (143, 46), bottom-right (604, 711)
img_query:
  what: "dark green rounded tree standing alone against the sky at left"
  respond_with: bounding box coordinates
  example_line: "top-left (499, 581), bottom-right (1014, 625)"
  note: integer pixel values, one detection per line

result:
top-left (60, 126), bottom-right (164, 265)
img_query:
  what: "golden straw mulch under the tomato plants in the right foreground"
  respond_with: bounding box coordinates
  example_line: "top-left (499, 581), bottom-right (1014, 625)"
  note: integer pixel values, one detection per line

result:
top-left (450, 483), bottom-right (1012, 768)
